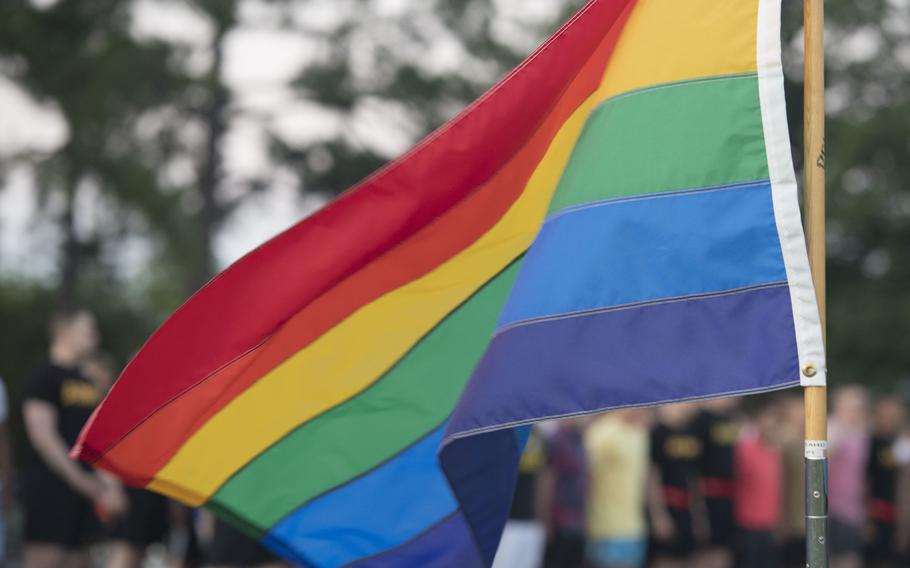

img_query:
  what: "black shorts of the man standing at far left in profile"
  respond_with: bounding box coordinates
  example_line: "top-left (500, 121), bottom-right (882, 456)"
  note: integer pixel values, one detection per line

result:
top-left (22, 468), bottom-right (101, 549)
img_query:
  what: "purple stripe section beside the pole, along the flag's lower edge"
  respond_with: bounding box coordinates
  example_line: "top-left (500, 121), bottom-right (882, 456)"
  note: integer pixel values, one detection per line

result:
top-left (446, 286), bottom-right (799, 440)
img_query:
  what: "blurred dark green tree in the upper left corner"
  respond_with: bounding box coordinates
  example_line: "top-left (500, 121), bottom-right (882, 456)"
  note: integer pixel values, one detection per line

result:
top-left (0, 0), bottom-right (194, 305)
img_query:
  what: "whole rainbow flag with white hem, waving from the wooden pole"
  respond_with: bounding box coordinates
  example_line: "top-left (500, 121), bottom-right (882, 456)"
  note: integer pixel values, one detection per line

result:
top-left (74, 0), bottom-right (825, 567)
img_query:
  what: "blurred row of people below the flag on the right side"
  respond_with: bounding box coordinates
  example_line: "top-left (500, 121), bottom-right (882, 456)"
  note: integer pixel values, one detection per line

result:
top-left (494, 385), bottom-right (910, 568)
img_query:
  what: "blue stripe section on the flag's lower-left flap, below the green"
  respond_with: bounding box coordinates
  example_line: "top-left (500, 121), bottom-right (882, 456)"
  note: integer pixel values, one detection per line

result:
top-left (263, 428), bottom-right (458, 568)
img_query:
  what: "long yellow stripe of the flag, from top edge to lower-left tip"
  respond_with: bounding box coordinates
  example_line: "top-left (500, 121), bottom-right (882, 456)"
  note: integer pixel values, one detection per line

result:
top-left (148, 0), bottom-right (757, 505)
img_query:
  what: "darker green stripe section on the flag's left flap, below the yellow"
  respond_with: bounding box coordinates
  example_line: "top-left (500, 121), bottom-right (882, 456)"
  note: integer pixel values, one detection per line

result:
top-left (212, 261), bottom-right (520, 532)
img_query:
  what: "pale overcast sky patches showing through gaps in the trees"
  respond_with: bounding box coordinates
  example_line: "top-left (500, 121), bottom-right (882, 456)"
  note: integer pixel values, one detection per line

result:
top-left (0, 0), bottom-right (560, 276)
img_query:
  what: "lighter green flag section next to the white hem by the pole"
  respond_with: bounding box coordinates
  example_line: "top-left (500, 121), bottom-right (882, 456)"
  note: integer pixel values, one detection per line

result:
top-left (550, 74), bottom-right (768, 213)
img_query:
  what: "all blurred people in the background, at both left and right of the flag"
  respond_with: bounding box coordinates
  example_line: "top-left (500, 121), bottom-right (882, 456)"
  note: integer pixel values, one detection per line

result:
top-left (0, 309), bottom-right (910, 568)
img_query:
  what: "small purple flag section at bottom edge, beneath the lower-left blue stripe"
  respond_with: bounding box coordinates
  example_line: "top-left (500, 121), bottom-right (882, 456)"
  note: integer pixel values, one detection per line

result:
top-left (353, 512), bottom-right (483, 568)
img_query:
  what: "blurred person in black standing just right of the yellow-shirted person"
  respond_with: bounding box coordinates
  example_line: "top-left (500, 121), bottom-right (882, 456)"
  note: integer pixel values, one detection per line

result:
top-left (648, 403), bottom-right (702, 568)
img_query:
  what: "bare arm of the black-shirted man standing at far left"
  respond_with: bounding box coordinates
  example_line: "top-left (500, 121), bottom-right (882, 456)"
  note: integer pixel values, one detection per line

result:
top-left (22, 399), bottom-right (105, 501)
